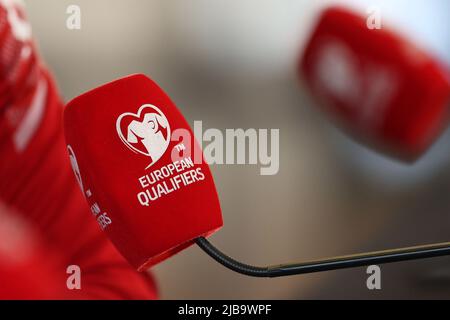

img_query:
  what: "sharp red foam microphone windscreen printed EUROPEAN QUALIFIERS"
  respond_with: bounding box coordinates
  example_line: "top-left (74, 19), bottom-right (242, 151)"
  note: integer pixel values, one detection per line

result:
top-left (64, 75), bottom-right (223, 271)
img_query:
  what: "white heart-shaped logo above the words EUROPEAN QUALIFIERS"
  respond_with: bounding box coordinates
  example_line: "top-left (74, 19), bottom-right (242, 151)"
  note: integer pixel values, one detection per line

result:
top-left (116, 104), bottom-right (171, 169)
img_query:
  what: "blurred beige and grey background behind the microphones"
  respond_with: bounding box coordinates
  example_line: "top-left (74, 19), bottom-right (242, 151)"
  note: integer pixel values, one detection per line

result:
top-left (25, 0), bottom-right (450, 299)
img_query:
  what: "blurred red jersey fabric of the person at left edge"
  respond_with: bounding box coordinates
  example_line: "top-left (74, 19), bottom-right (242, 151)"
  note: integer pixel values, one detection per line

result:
top-left (0, 2), bottom-right (157, 299)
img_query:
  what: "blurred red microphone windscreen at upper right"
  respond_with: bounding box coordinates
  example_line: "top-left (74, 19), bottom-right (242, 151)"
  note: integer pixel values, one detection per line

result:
top-left (299, 7), bottom-right (450, 161)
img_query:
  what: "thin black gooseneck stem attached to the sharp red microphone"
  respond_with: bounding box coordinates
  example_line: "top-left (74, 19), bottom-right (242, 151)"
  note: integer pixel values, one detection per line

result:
top-left (196, 237), bottom-right (450, 278)
